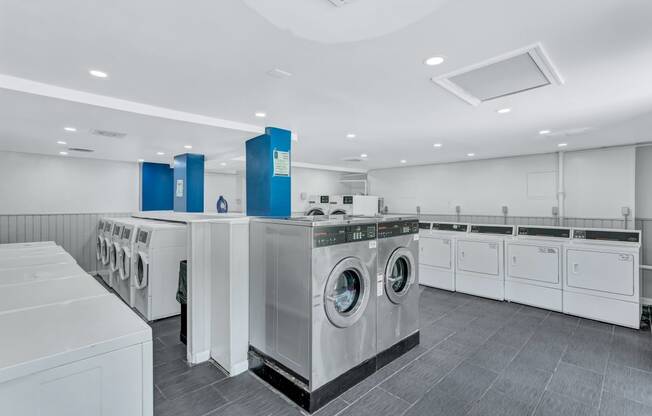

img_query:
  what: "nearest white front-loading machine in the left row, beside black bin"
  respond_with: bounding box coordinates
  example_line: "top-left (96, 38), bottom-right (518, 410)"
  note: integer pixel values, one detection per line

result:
top-left (132, 222), bottom-right (188, 321)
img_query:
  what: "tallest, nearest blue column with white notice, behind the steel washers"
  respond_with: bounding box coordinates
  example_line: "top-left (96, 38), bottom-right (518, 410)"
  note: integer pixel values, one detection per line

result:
top-left (246, 127), bottom-right (292, 217)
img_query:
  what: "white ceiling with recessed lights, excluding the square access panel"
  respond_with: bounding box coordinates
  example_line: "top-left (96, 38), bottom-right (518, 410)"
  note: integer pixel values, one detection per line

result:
top-left (0, 0), bottom-right (652, 169)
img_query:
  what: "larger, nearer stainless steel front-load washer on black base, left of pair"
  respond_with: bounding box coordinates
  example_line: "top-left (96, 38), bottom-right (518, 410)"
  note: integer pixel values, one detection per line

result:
top-left (249, 217), bottom-right (377, 412)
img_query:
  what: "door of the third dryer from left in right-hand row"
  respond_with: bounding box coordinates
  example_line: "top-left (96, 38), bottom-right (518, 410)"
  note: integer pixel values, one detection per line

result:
top-left (507, 244), bottom-right (561, 283)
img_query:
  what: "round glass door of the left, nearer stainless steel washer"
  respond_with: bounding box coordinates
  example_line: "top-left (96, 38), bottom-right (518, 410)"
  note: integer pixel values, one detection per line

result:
top-left (324, 257), bottom-right (371, 328)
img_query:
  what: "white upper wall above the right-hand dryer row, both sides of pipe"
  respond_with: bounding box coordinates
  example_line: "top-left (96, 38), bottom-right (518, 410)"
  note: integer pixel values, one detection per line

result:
top-left (368, 147), bottom-right (635, 218)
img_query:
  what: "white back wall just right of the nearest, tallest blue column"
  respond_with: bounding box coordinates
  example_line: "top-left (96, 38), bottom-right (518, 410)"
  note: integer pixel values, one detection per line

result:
top-left (292, 167), bottom-right (347, 212)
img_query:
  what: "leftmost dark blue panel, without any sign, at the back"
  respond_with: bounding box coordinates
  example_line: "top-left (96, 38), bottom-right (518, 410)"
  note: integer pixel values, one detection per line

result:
top-left (140, 162), bottom-right (174, 211)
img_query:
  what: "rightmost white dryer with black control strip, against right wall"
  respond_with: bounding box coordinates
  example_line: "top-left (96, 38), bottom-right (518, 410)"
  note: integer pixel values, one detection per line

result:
top-left (563, 228), bottom-right (641, 329)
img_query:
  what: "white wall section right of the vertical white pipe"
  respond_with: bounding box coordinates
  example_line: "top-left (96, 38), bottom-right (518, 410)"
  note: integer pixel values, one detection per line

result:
top-left (564, 146), bottom-right (636, 219)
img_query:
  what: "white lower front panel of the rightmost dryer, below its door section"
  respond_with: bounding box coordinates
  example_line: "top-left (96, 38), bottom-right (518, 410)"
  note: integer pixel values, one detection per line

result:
top-left (563, 291), bottom-right (641, 329)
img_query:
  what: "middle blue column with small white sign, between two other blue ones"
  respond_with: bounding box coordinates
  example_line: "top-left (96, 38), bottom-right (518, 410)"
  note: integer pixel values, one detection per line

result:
top-left (173, 153), bottom-right (204, 212)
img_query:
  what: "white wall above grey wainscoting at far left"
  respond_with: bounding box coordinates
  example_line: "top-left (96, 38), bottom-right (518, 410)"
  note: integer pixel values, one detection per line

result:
top-left (0, 152), bottom-right (139, 214)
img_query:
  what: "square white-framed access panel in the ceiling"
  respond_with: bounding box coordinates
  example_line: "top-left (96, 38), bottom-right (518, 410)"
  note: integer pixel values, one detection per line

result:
top-left (432, 44), bottom-right (564, 106)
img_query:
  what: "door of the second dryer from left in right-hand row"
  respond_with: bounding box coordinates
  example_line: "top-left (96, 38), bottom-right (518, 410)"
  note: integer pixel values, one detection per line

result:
top-left (457, 240), bottom-right (502, 276)
